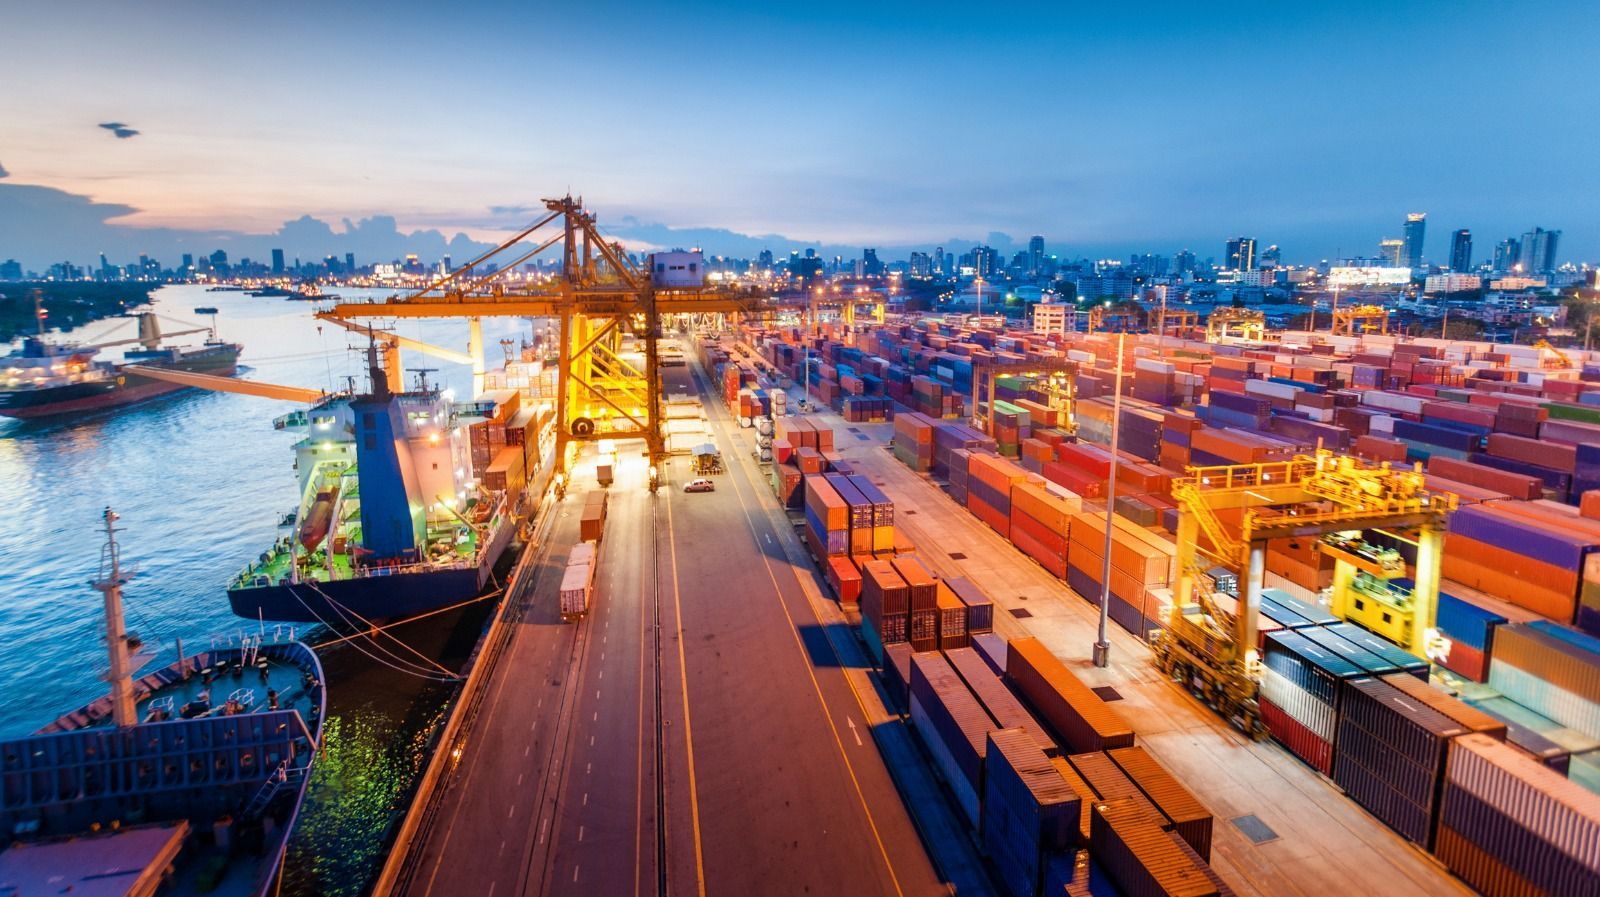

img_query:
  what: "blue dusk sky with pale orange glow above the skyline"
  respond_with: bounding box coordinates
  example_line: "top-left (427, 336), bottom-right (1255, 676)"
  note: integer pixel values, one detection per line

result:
top-left (0, 0), bottom-right (1600, 264)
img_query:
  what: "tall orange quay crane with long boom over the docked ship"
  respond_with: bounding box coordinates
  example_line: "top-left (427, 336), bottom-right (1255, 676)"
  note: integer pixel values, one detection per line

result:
top-left (323, 195), bottom-right (766, 488)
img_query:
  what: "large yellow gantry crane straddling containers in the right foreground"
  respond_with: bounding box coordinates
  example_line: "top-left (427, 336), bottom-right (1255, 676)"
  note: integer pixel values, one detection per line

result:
top-left (1157, 449), bottom-right (1456, 737)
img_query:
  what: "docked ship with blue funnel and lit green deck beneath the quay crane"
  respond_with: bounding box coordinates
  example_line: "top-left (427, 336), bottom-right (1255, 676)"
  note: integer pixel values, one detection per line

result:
top-left (227, 349), bottom-right (547, 628)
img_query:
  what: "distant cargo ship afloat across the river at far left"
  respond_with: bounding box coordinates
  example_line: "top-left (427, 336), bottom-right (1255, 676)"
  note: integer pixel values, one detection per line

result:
top-left (0, 299), bottom-right (242, 419)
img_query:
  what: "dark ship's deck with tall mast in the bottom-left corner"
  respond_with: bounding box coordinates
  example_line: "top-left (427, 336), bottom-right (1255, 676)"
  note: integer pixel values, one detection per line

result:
top-left (0, 508), bottom-right (326, 897)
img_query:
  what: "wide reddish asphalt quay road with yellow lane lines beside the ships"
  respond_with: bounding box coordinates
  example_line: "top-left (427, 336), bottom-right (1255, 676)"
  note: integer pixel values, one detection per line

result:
top-left (406, 346), bottom-right (947, 897)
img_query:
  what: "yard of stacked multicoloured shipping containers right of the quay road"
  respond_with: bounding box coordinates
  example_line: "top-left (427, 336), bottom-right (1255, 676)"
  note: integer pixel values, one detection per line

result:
top-left (701, 306), bottom-right (1600, 895)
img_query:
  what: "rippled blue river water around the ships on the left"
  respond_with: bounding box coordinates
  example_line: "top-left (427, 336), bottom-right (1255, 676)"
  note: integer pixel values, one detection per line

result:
top-left (0, 286), bottom-right (526, 897)
